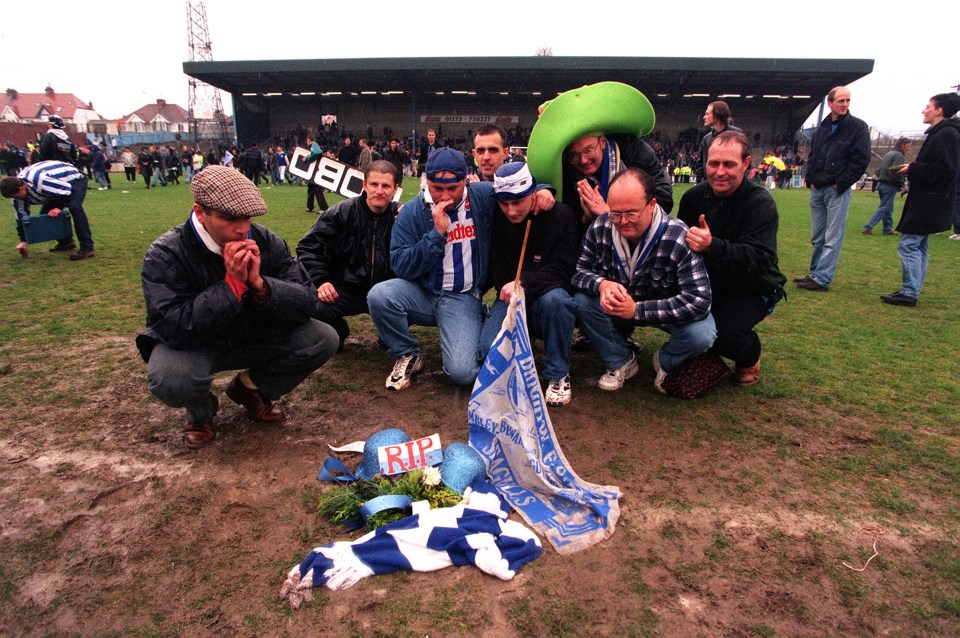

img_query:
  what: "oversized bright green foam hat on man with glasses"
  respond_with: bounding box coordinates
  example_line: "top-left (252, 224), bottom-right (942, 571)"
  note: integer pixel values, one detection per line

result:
top-left (527, 82), bottom-right (656, 200)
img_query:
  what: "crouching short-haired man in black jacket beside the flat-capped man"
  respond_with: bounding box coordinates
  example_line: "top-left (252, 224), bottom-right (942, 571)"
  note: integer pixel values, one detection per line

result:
top-left (297, 160), bottom-right (397, 349)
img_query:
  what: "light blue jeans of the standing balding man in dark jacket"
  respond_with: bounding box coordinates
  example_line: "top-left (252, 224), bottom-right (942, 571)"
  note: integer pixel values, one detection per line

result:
top-left (810, 186), bottom-right (852, 288)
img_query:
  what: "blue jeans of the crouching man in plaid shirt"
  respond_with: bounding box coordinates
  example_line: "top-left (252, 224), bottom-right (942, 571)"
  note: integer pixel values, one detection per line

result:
top-left (573, 292), bottom-right (717, 372)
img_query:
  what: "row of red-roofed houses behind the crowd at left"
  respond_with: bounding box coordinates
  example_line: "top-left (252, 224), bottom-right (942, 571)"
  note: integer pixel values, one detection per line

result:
top-left (0, 86), bottom-right (230, 143)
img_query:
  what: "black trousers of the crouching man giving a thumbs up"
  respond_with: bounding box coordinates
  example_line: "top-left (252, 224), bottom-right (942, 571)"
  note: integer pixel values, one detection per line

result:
top-left (710, 294), bottom-right (768, 368)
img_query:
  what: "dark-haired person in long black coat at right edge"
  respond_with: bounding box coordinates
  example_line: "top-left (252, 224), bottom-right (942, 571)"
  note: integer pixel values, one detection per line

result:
top-left (880, 93), bottom-right (960, 306)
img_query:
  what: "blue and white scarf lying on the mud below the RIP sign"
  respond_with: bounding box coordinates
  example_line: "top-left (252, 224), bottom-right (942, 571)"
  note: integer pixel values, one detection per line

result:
top-left (280, 490), bottom-right (543, 609)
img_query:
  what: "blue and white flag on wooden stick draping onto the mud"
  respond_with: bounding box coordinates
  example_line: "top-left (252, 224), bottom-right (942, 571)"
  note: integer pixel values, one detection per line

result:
top-left (468, 286), bottom-right (620, 554)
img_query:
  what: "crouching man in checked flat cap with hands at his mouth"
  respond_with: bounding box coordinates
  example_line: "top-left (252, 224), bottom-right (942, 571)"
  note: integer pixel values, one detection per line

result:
top-left (137, 166), bottom-right (339, 449)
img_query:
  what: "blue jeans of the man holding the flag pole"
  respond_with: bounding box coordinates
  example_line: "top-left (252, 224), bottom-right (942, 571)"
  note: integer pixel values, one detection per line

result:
top-left (480, 288), bottom-right (577, 381)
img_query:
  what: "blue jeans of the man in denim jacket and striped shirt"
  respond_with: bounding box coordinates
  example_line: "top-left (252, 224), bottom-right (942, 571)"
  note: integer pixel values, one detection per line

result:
top-left (367, 279), bottom-right (486, 385)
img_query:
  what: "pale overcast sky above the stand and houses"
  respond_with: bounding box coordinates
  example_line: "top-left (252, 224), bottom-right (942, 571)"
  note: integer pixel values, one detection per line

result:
top-left (0, 0), bottom-right (960, 134)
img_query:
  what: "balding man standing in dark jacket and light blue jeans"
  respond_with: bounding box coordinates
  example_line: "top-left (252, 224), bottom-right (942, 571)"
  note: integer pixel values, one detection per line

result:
top-left (793, 86), bottom-right (870, 292)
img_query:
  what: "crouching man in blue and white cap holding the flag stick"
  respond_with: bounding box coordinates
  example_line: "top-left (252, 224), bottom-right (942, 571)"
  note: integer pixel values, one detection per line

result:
top-left (480, 162), bottom-right (580, 405)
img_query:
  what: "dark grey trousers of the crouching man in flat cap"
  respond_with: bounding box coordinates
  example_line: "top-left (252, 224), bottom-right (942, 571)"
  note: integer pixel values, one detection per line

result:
top-left (147, 319), bottom-right (340, 425)
